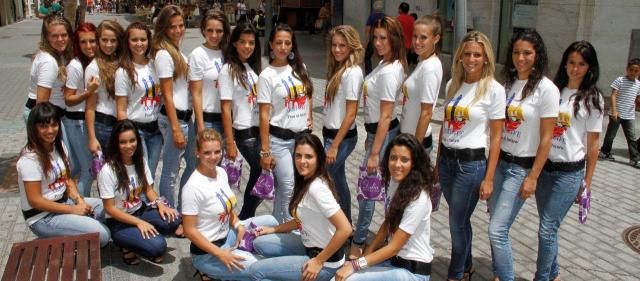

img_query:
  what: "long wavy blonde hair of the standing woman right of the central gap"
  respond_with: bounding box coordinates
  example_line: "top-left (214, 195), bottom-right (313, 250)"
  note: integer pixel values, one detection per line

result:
top-left (324, 25), bottom-right (364, 103)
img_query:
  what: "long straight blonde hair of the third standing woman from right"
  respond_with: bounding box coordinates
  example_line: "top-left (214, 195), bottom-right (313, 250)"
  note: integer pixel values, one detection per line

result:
top-left (446, 31), bottom-right (496, 104)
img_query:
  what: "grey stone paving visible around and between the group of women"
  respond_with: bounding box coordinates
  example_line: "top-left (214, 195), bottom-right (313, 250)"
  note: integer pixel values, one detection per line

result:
top-left (0, 14), bottom-right (640, 281)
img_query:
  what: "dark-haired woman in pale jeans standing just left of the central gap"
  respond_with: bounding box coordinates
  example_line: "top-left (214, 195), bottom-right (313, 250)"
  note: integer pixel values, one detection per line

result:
top-left (258, 24), bottom-right (313, 223)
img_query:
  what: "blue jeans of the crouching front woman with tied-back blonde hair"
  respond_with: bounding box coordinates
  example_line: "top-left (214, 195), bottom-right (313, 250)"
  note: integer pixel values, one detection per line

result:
top-left (191, 215), bottom-right (278, 281)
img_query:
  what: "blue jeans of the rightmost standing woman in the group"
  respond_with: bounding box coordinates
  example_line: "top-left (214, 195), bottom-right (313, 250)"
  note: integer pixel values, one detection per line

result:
top-left (534, 169), bottom-right (584, 281)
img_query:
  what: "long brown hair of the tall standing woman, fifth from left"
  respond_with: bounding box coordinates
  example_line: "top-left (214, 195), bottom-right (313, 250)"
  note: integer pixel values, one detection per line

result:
top-left (151, 5), bottom-right (189, 80)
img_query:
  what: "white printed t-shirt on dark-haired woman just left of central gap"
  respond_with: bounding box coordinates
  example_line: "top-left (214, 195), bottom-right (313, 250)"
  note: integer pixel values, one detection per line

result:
top-left (258, 64), bottom-right (310, 132)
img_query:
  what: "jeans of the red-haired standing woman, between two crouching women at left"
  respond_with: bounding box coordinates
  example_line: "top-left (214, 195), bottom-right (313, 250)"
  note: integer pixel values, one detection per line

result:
top-left (62, 117), bottom-right (93, 197)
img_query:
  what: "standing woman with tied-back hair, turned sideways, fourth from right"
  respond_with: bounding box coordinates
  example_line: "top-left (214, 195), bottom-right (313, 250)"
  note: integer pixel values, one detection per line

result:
top-left (400, 15), bottom-right (442, 154)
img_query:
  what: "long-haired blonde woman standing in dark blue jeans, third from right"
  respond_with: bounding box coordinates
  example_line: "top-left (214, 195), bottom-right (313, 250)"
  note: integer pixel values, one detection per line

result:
top-left (438, 31), bottom-right (505, 280)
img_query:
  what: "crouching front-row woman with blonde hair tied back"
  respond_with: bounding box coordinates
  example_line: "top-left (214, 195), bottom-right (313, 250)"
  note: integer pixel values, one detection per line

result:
top-left (182, 129), bottom-right (278, 280)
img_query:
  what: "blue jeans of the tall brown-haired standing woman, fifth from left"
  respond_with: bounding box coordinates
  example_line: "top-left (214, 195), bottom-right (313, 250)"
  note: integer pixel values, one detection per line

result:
top-left (158, 114), bottom-right (193, 211)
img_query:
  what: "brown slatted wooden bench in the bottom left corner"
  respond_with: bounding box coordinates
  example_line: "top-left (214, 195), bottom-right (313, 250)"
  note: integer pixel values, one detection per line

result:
top-left (2, 233), bottom-right (102, 281)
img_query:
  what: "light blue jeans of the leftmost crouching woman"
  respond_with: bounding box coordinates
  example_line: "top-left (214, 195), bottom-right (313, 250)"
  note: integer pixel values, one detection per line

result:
top-left (29, 197), bottom-right (111, 247)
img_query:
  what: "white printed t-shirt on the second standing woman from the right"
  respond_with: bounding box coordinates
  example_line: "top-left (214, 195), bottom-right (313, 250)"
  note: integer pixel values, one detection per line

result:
top-left (500, 77), bottom-right (560, 157)
